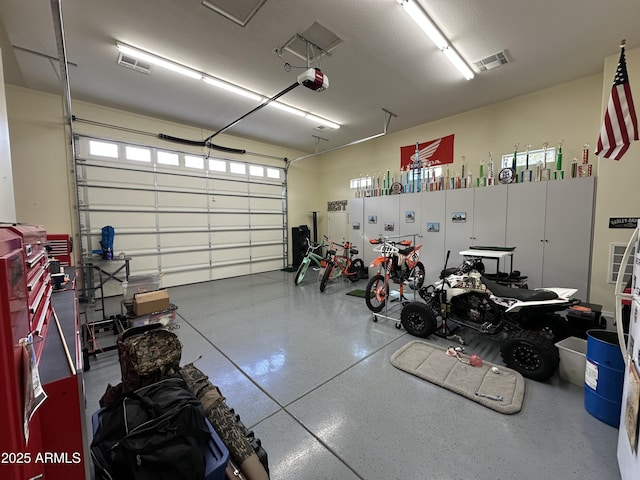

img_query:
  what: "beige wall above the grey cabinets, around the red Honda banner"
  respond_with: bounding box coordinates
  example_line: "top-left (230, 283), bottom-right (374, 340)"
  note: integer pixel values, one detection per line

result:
top-left (314, 74), bottom-right (602, 206)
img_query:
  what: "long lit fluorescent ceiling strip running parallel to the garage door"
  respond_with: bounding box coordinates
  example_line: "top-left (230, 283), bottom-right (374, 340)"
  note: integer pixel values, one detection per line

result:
top-left (116, 42), bottom-right (340, 129)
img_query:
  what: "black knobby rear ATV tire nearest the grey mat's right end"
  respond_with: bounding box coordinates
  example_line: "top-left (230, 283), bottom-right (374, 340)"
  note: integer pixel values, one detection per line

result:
top-left (500, 330), bottom-right (560, 382)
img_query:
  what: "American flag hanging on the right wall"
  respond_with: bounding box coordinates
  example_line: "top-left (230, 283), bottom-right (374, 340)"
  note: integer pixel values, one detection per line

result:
top-left (596, 46), bottom-right (638, 160)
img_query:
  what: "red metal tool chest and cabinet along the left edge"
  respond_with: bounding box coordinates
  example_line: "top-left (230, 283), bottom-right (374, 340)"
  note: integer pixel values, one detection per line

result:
top-left (0, 224), bottom-right (88, 480)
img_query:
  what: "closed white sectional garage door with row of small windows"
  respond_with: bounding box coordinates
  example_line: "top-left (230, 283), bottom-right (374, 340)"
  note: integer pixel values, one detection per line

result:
top-left (76, 137), bottom-right (286, 296)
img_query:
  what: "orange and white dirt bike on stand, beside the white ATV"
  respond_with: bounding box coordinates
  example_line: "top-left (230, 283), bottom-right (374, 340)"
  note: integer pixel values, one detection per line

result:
top-left (364, 237), bottom-right (425, 313)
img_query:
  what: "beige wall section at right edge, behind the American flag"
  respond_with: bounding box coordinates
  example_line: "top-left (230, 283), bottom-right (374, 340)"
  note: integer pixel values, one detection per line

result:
top-left (591, 48), bottom-right (640, 311)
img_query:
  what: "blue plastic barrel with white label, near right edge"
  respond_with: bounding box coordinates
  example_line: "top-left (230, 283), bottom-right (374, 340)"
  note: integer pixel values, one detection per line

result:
top-left (584, 330), bottom-right (626, 428)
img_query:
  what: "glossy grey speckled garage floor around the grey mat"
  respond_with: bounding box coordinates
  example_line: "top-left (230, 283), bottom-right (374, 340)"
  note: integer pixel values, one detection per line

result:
top-left (83, 271), bottom-right (620, 480)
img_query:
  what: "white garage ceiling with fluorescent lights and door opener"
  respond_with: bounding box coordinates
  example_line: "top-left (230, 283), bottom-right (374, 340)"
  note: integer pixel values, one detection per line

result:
top-left (0, 0), bottom-right (640, 152)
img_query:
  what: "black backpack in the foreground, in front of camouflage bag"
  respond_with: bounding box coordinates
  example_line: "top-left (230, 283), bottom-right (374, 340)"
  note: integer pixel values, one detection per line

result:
top-left (91, 377), bottom-right (211, 480)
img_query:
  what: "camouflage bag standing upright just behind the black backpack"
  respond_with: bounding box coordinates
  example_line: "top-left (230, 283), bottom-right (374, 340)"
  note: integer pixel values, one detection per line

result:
top-left (118, 323), bottom-right (182, 392)
